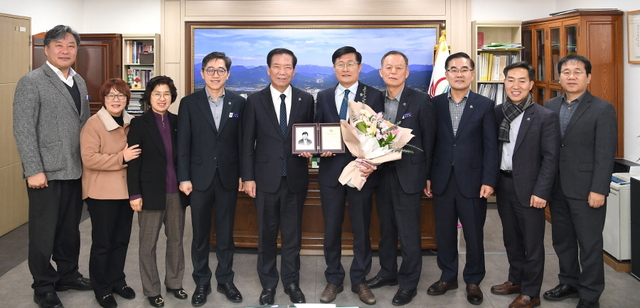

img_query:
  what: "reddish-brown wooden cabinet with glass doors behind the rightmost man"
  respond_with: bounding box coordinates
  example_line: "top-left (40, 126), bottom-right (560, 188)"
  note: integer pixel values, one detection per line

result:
top-left (522, 11), bottom-right (624, 157)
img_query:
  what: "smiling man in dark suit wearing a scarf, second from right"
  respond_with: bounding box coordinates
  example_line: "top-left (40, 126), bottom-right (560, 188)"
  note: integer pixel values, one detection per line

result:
top-left (491, 62), bottom-right (560, 308)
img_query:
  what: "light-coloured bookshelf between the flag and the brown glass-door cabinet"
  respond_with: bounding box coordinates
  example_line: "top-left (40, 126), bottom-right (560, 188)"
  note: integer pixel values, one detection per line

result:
top-left (471, 20), bottom-right (522, 104)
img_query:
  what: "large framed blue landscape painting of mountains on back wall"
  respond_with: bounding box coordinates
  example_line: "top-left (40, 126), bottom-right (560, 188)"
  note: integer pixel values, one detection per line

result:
top-left (185, 21), bottom-right (441, 97)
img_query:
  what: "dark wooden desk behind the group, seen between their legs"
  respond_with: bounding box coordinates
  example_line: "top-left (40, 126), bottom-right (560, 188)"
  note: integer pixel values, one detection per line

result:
top-left (211, 169), bottom-right (437, 253)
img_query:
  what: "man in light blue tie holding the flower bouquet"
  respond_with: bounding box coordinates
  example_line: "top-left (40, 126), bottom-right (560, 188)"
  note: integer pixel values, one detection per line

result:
top-left (315, 46), bottom-right (384, 305)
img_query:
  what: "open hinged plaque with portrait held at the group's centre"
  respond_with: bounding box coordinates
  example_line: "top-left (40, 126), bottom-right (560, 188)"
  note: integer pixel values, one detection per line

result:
top-left (291, 123), bottom-right (345, 154)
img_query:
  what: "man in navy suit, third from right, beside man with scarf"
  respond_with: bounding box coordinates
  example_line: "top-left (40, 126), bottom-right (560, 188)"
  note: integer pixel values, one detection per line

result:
top-left (425, 52), bottom-right (498, 305)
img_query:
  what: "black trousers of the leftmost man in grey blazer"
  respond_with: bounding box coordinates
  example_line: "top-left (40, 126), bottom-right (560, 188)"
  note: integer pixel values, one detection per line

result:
top-left (27, 180), bottom-right (82, 294)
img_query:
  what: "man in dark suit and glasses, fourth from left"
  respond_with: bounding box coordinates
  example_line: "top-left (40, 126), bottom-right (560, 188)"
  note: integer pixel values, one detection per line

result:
top-left (178, 52), bottom-right (245, 306)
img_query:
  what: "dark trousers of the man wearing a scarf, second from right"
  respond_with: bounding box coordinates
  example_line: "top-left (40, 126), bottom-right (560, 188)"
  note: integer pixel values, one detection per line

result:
top-left (496, 175), bottom-right (545, 297)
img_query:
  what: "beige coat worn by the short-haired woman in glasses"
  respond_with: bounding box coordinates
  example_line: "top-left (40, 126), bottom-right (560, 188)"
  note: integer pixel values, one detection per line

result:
top-left (80, 107), bottom-right (131, 200)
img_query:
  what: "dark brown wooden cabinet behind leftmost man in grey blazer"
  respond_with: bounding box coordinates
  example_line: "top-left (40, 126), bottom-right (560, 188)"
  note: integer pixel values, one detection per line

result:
top-left (32, 32), bottom-right (122, 114)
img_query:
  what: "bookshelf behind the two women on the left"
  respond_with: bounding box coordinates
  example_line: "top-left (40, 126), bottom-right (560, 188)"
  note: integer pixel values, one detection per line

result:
top-left (122, 34), bottom-right (160, 114)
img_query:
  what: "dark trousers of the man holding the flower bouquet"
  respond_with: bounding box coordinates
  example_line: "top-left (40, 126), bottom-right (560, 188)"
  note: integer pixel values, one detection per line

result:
top-left (320, 185), bottom-right (373, 285)
